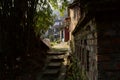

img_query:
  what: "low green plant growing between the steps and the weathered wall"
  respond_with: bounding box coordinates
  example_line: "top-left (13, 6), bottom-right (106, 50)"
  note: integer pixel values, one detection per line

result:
top-left (66, 55), bottom-right (87, 80)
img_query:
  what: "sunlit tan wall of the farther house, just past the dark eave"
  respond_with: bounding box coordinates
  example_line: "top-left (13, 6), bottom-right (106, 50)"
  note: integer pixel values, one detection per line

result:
top-left (68, 4), bottom-right (81, 52)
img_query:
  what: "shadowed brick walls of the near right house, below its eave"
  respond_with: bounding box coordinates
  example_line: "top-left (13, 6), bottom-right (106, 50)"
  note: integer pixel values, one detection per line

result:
top-left (74, 11), bottom-right (120, 80)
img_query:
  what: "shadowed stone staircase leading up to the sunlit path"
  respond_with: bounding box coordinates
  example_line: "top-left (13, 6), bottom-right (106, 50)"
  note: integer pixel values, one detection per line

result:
top-left (39, 52), bottom-right (68, 80)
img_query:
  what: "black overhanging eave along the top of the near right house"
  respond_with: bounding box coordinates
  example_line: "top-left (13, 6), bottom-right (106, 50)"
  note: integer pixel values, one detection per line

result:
top-left (72, 0), bottom-right (120, 35)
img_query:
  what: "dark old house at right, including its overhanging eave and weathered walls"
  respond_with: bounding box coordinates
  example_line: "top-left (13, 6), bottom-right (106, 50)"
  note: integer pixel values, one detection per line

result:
top-left (69, 0), bottom-right (120, 80)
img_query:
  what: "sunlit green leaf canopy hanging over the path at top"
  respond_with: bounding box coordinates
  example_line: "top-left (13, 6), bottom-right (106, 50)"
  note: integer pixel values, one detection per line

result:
top-left (35, 0), bottom-right (68, 35)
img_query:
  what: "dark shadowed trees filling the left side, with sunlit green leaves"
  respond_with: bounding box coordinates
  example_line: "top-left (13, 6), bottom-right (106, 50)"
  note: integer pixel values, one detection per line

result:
top-left (0, 0), bottom-right (68, 80)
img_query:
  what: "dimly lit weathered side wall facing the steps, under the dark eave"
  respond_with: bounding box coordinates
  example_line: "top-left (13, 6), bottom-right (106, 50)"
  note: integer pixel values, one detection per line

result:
top-left (75, 19), bottom-right (97, 80)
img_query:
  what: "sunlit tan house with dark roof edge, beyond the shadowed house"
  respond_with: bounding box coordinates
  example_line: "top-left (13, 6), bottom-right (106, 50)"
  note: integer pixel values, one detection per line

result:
top-left (67, 1), bottom-right (81, 51)
